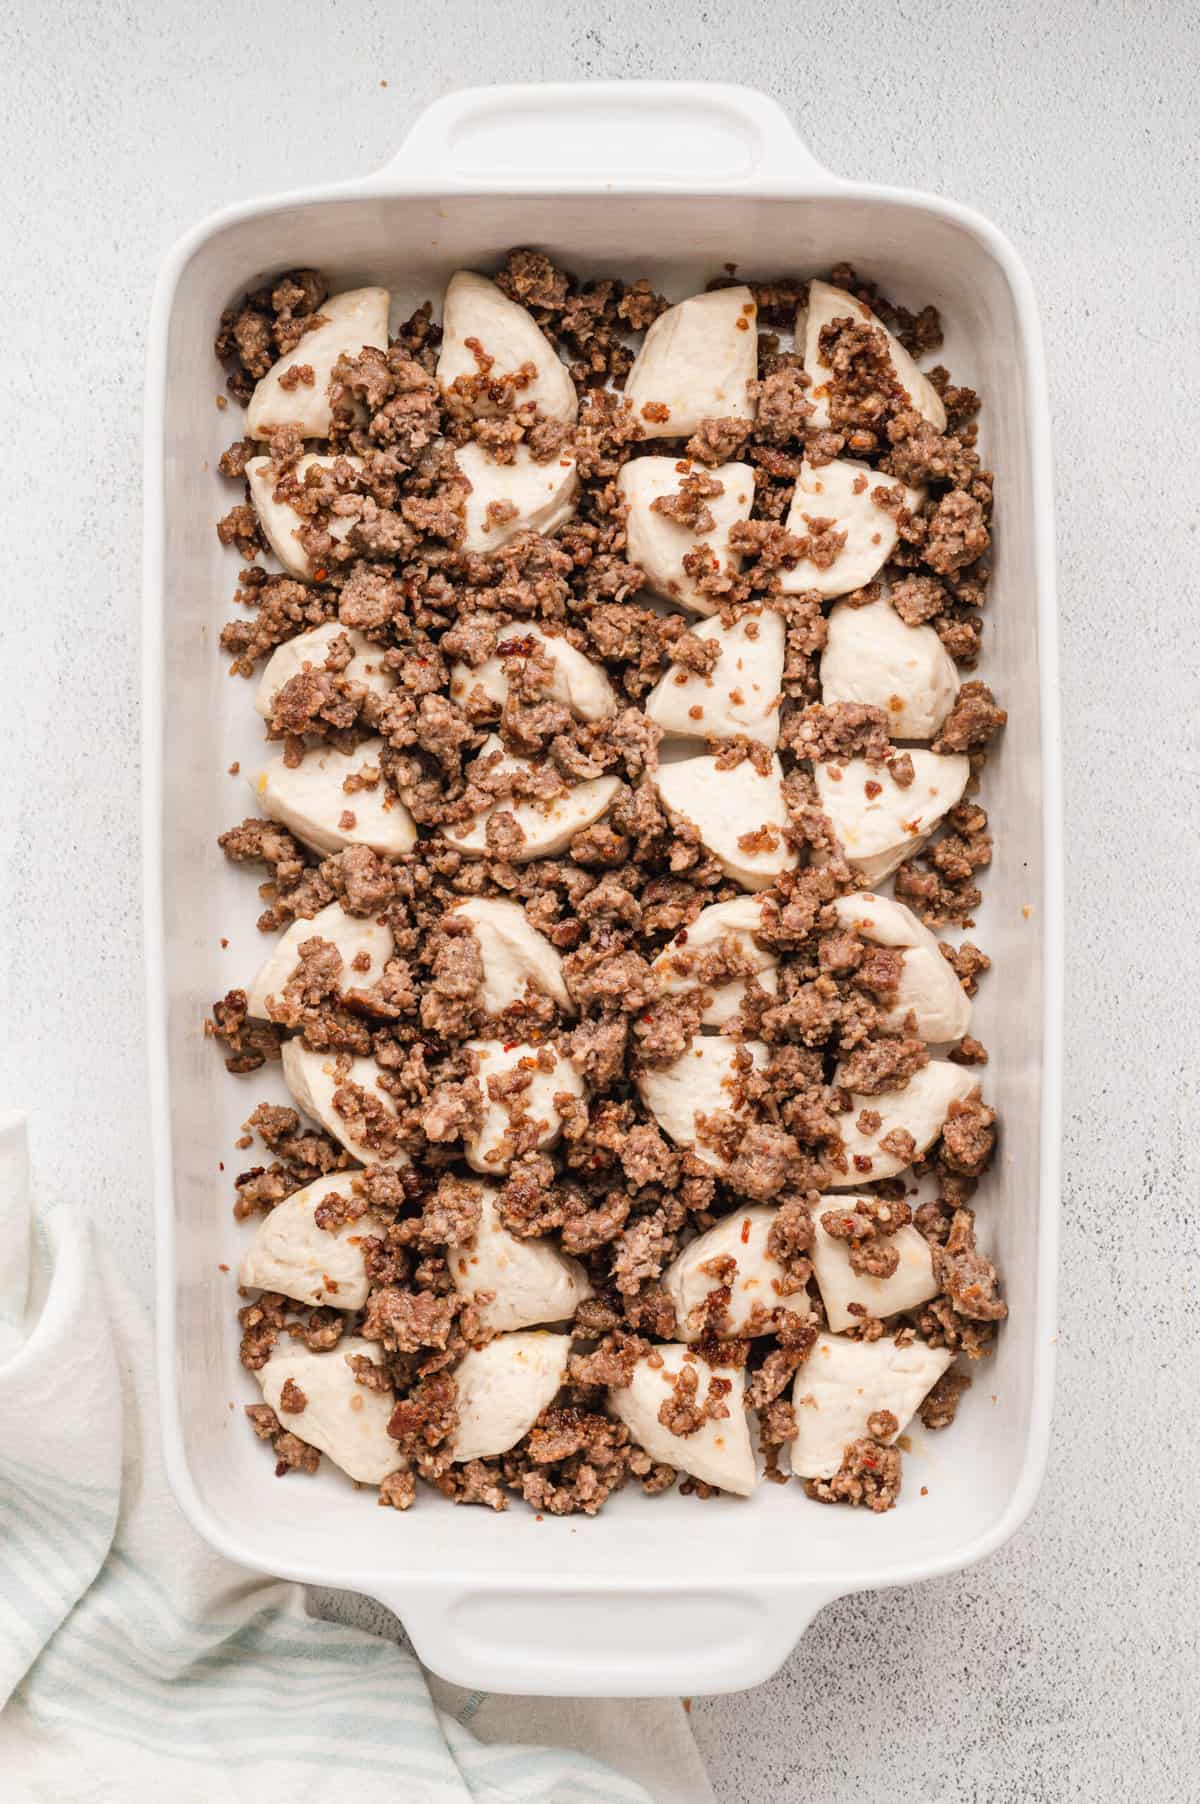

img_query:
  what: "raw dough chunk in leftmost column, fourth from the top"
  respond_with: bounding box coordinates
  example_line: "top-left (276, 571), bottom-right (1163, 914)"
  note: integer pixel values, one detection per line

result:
top-left (254, 740), bottom-right (417, 859)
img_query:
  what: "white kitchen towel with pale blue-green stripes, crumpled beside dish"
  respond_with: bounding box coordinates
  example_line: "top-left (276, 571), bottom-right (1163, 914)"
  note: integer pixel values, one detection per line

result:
top-left (0, 1113), bottom-right (713, 1804)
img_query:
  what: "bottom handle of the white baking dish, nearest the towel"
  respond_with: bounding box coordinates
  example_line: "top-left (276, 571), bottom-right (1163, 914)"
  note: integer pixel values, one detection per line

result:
top-left (377, 1579), bottom-right (839, 1698)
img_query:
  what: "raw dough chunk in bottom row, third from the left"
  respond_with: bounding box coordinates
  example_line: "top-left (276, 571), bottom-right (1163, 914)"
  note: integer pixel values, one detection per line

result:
top-left (608, 1342), bottom-right (758, 1497)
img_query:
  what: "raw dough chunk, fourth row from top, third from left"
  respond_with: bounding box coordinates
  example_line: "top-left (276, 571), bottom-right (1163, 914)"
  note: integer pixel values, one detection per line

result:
top-left (653, 756), bottom-right (793, 889)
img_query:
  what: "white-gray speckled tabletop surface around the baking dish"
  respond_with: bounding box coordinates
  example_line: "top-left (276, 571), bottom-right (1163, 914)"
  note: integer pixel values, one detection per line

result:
top-left (0, 0), bottom-right (1200, 1804)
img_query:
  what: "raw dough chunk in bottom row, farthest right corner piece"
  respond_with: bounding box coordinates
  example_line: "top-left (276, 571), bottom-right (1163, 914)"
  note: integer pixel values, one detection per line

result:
top-left (792, 1335), bottom-right (955, 1477)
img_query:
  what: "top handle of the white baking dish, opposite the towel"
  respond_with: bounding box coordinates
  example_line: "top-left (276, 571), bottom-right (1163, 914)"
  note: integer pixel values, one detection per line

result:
top-left (368, 81), bottom-right (843, 193)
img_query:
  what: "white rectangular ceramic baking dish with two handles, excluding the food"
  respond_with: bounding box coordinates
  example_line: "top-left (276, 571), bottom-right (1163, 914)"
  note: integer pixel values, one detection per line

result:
top-left (144, 83), bottom-right (1061, 1696)
